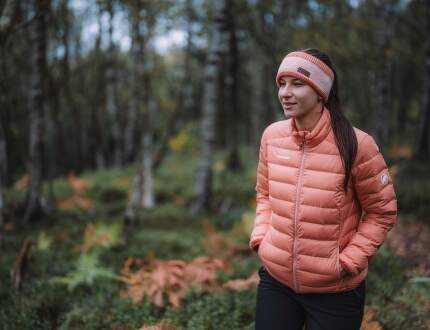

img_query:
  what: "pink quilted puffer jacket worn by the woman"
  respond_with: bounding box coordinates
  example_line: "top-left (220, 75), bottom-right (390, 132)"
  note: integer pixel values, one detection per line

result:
top-left (249, 108), bottom-right (397, 293)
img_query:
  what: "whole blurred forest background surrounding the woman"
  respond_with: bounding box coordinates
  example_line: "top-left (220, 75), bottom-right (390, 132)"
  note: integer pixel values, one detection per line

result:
top-left (0, 0), bottom-right (430, 329)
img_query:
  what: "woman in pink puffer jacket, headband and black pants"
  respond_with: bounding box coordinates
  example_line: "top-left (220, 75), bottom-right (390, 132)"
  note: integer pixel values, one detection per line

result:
top-left (249, 48), bottom-right (397, 330)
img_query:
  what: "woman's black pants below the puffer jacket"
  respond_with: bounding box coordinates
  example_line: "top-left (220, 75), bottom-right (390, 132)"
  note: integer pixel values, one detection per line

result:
top-left (255, 266), bottom-right (366, 330)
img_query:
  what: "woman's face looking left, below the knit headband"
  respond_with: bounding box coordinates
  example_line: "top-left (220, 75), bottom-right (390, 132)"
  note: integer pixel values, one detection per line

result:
top-left (278, 76), bottom-right (322, 119)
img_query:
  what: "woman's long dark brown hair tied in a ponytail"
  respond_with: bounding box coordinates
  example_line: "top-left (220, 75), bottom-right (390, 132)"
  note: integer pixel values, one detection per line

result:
top-left (300, 48), bottom-right (358, 193)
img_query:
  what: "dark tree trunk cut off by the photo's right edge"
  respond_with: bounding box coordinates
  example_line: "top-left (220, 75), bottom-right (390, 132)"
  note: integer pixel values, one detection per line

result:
top-left (415, 0), bottom-right (430, 161)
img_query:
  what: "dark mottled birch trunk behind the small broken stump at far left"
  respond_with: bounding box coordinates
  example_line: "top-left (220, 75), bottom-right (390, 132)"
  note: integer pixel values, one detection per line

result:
top-left (23, 0), bottom-right (49, 223)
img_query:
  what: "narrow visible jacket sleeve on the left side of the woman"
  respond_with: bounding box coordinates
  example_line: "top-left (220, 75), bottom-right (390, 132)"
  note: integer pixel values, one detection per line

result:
top-left (249, 129), bottom-right (271, 250)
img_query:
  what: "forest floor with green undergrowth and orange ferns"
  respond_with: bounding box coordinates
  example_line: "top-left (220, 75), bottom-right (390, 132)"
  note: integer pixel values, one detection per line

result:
top-left (0, 151), bottom-right (430, 330)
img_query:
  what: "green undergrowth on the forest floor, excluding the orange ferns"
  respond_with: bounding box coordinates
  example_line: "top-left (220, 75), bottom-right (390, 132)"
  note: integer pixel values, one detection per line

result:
top-left (0, 150), bottom-right (430, 329)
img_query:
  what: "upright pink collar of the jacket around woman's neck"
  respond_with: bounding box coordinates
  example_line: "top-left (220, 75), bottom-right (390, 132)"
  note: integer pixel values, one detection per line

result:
top-left (291, 107), bottom-right (331, 147)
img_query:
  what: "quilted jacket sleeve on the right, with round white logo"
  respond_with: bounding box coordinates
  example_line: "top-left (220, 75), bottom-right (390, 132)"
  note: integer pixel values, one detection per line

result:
top-left (339, 134), bottom-right (397, 275)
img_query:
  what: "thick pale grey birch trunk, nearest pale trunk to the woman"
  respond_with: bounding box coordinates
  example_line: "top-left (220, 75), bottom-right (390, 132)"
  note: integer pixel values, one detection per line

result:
top-left (191, 0), bottom-right (226, 213)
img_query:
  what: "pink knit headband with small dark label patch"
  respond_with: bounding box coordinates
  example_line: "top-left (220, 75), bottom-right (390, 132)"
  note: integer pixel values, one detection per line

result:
top-left (276, 51), bottom-right (334, 102)
